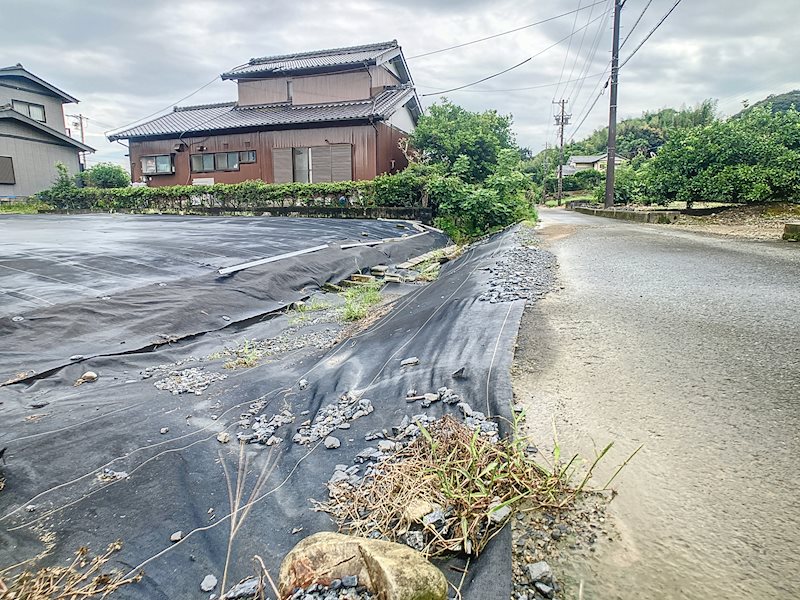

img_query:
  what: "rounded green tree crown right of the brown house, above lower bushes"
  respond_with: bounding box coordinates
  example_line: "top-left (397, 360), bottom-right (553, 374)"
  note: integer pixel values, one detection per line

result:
top-left (411, 99), bottom-right (520, 183)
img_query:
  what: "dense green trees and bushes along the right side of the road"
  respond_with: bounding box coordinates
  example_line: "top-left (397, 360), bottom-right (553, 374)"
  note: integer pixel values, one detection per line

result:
top-left (525, 92), bottom-right (800, 208)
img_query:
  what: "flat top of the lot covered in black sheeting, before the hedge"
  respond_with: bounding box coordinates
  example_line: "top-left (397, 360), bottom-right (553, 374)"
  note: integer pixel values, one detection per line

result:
top-left (0, 214), bottom-right (414, 317)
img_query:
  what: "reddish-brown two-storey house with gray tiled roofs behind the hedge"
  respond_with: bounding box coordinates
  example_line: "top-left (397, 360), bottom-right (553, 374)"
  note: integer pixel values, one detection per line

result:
top-left (108, 40), bottom-right (420, 186)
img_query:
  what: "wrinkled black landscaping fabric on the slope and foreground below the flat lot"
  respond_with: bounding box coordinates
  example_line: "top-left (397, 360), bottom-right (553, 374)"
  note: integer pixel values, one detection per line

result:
top-left (0, 223), bottom-right (524, 600)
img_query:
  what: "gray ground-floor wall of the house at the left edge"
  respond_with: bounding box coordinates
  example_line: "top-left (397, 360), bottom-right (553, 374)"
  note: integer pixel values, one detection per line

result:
top-left (0, 119), bottom-right (80, 198)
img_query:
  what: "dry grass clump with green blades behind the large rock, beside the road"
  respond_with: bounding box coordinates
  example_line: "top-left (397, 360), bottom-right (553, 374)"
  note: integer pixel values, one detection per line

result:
top-left (320, 416), bottom-right (575, 556)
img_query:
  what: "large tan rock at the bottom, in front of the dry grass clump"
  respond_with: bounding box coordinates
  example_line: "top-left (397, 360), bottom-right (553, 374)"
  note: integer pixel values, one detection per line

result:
top-left (279, 532), bottom-right (447, 600)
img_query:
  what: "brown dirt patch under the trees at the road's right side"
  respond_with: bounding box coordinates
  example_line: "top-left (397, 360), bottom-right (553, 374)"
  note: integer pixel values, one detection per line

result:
top-left (672, 203), bottom-right (800, 240)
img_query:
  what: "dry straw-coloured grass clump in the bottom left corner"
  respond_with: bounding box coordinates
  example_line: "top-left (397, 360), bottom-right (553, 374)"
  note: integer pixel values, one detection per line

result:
top-left (0, 540), bottom-right (142, 600)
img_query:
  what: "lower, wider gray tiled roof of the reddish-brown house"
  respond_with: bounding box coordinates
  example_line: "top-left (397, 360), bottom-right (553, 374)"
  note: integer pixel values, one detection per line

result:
top-left (108, 86), bottom-right (414, 141)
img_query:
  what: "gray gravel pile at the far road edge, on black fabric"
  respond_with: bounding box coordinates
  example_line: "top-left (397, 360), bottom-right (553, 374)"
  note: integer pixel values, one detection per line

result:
top-left (478, 228), bottom-right (556, 304)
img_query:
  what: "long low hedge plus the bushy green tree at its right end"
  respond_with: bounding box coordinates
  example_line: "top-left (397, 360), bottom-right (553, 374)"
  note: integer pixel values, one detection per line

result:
top-left (37, 100), bottom-right (540, 242)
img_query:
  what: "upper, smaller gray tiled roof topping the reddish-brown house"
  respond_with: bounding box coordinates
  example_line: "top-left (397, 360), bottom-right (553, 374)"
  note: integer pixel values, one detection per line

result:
top-left (221, 40), bottom-right (399, 79)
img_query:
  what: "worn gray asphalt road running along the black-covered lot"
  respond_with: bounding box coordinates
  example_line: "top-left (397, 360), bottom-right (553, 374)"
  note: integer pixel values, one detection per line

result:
top-left (515, 210), bottom-right (800, 600)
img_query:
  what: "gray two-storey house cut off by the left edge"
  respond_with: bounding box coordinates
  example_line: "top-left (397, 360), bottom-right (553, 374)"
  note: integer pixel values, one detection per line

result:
top-left (0, 64), bottom-right (94, 199)
